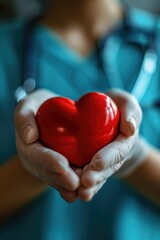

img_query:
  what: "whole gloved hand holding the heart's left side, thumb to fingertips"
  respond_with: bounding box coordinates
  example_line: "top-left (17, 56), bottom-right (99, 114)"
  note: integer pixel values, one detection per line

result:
top-left (14, 90), bottom-right (80, 202)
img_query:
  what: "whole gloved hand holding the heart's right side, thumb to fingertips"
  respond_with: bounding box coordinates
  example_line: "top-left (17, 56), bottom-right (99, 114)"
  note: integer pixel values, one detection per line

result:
top-left (78, 90), bottom-right (145, 201)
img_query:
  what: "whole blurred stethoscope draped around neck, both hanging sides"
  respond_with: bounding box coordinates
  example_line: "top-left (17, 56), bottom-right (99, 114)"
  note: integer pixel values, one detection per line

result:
top-left (15, 8), bottom-right (160, 110)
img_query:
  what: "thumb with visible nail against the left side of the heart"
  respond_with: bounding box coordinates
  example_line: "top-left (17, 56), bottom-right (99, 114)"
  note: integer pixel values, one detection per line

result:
top-left (14, 100), bottom-right (39, 144)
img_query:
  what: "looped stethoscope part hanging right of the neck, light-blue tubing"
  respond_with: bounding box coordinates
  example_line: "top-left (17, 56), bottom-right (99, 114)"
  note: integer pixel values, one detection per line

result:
top-left (98, 9), bottom-right (160, 110)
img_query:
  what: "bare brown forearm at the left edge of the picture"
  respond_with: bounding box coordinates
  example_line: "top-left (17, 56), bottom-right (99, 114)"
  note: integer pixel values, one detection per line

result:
top-left (0, 156), bottom-right (46, 222)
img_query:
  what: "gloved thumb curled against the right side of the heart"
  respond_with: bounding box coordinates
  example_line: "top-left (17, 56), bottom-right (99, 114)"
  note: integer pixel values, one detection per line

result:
top-left (108, 89), bottom-right (142, 136)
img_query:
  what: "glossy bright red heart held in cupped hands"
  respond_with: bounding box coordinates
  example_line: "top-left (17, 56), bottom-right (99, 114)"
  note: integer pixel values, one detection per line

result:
top-left (36, 92), bottom-right (120, 167)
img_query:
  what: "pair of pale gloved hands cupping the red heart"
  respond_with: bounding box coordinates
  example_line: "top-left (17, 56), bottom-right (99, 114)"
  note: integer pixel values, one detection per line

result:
top-left (15, 90), bottom-right (142, 202)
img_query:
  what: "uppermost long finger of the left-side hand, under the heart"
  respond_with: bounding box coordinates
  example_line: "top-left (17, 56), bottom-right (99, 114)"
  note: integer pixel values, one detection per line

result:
top-left (17, 132), bottom-right (80, 191)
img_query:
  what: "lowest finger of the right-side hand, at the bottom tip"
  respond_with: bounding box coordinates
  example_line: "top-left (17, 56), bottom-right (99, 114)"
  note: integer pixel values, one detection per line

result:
top-left (78, 180), bottom-right (106, 202)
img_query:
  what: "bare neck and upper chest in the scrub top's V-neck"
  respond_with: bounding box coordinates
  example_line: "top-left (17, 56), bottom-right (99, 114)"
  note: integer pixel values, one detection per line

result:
top-left (41, 0), bottom-right (123, 56)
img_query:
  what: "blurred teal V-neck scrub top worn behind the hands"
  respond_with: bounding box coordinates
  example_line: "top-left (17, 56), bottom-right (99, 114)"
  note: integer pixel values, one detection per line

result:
top-left (0, 8), bottom-right (160, 240)
